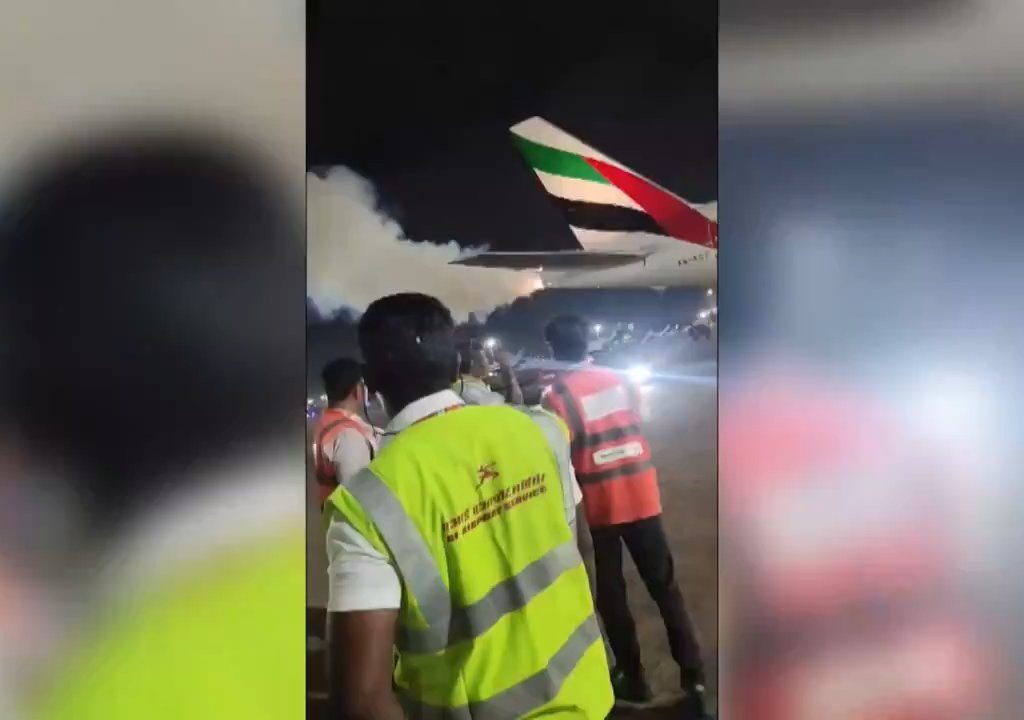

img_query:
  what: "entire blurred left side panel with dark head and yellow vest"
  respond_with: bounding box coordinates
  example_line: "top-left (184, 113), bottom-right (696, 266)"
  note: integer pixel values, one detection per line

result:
top-left (0, 0), bottom-right (305, 719)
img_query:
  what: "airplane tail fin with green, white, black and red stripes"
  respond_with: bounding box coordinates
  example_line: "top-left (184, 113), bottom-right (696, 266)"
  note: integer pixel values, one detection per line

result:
top-left (511, 117), bottom-right (718, 253)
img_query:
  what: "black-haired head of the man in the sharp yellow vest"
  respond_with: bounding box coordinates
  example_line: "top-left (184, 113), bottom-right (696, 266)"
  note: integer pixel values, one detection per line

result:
top-left (358, 293), bottom-right (459, 415)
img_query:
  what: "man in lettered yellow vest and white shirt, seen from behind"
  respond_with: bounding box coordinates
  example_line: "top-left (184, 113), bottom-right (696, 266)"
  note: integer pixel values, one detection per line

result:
top-left (326, 294), bottom-right (612, 720)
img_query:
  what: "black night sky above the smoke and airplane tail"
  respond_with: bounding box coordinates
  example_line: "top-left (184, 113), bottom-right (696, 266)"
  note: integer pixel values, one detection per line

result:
top-left (306, 0), bottom-right (718, 383)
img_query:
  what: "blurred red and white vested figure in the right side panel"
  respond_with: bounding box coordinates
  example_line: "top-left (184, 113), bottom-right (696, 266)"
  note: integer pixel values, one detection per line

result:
top-left (720, 369), bottom-right (996, 720)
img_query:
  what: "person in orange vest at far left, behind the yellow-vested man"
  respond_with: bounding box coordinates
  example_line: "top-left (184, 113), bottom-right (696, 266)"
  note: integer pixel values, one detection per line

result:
top-left (313, 357), bottom-right (378, 507)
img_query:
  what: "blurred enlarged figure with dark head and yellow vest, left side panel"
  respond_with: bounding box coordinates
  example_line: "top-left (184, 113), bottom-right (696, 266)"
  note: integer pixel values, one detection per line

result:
top-left (0, 130), bottom-right (305, 720)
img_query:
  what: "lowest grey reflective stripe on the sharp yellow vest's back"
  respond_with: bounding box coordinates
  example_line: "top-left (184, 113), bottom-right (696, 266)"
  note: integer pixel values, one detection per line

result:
top-left (399, 615), bottom-right (601, 720)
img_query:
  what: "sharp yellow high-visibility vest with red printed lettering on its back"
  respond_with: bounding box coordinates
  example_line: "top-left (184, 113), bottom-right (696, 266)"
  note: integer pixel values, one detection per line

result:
top-left (328, 406), bottom-right (612, 720)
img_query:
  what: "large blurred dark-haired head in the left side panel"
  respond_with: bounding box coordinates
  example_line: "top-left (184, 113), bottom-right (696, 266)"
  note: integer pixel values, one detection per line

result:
top-left (0, 130), bottom-right (304, 530)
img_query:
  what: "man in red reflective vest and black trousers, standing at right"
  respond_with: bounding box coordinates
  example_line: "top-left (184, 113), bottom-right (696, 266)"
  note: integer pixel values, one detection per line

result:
top-left (544, 315), bottom-right (705, 717)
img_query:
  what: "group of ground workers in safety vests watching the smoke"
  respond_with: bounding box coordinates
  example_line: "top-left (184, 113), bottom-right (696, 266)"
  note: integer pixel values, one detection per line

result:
top-left (313, 294), bottom-right (707, 720)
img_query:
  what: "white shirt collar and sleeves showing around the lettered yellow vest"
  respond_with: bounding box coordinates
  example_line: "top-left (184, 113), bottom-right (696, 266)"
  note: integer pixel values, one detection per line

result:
top-left (327, 390), bottom-right (580, 612)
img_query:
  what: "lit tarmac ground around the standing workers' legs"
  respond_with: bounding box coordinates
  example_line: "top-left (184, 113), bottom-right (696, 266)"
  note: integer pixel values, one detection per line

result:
top-left (307, 352), bottom-right (718, 720)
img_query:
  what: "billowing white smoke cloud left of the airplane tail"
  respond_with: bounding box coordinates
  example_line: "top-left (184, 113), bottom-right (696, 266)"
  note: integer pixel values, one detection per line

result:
top-left (306, 167), bottom-right (540, 321)
